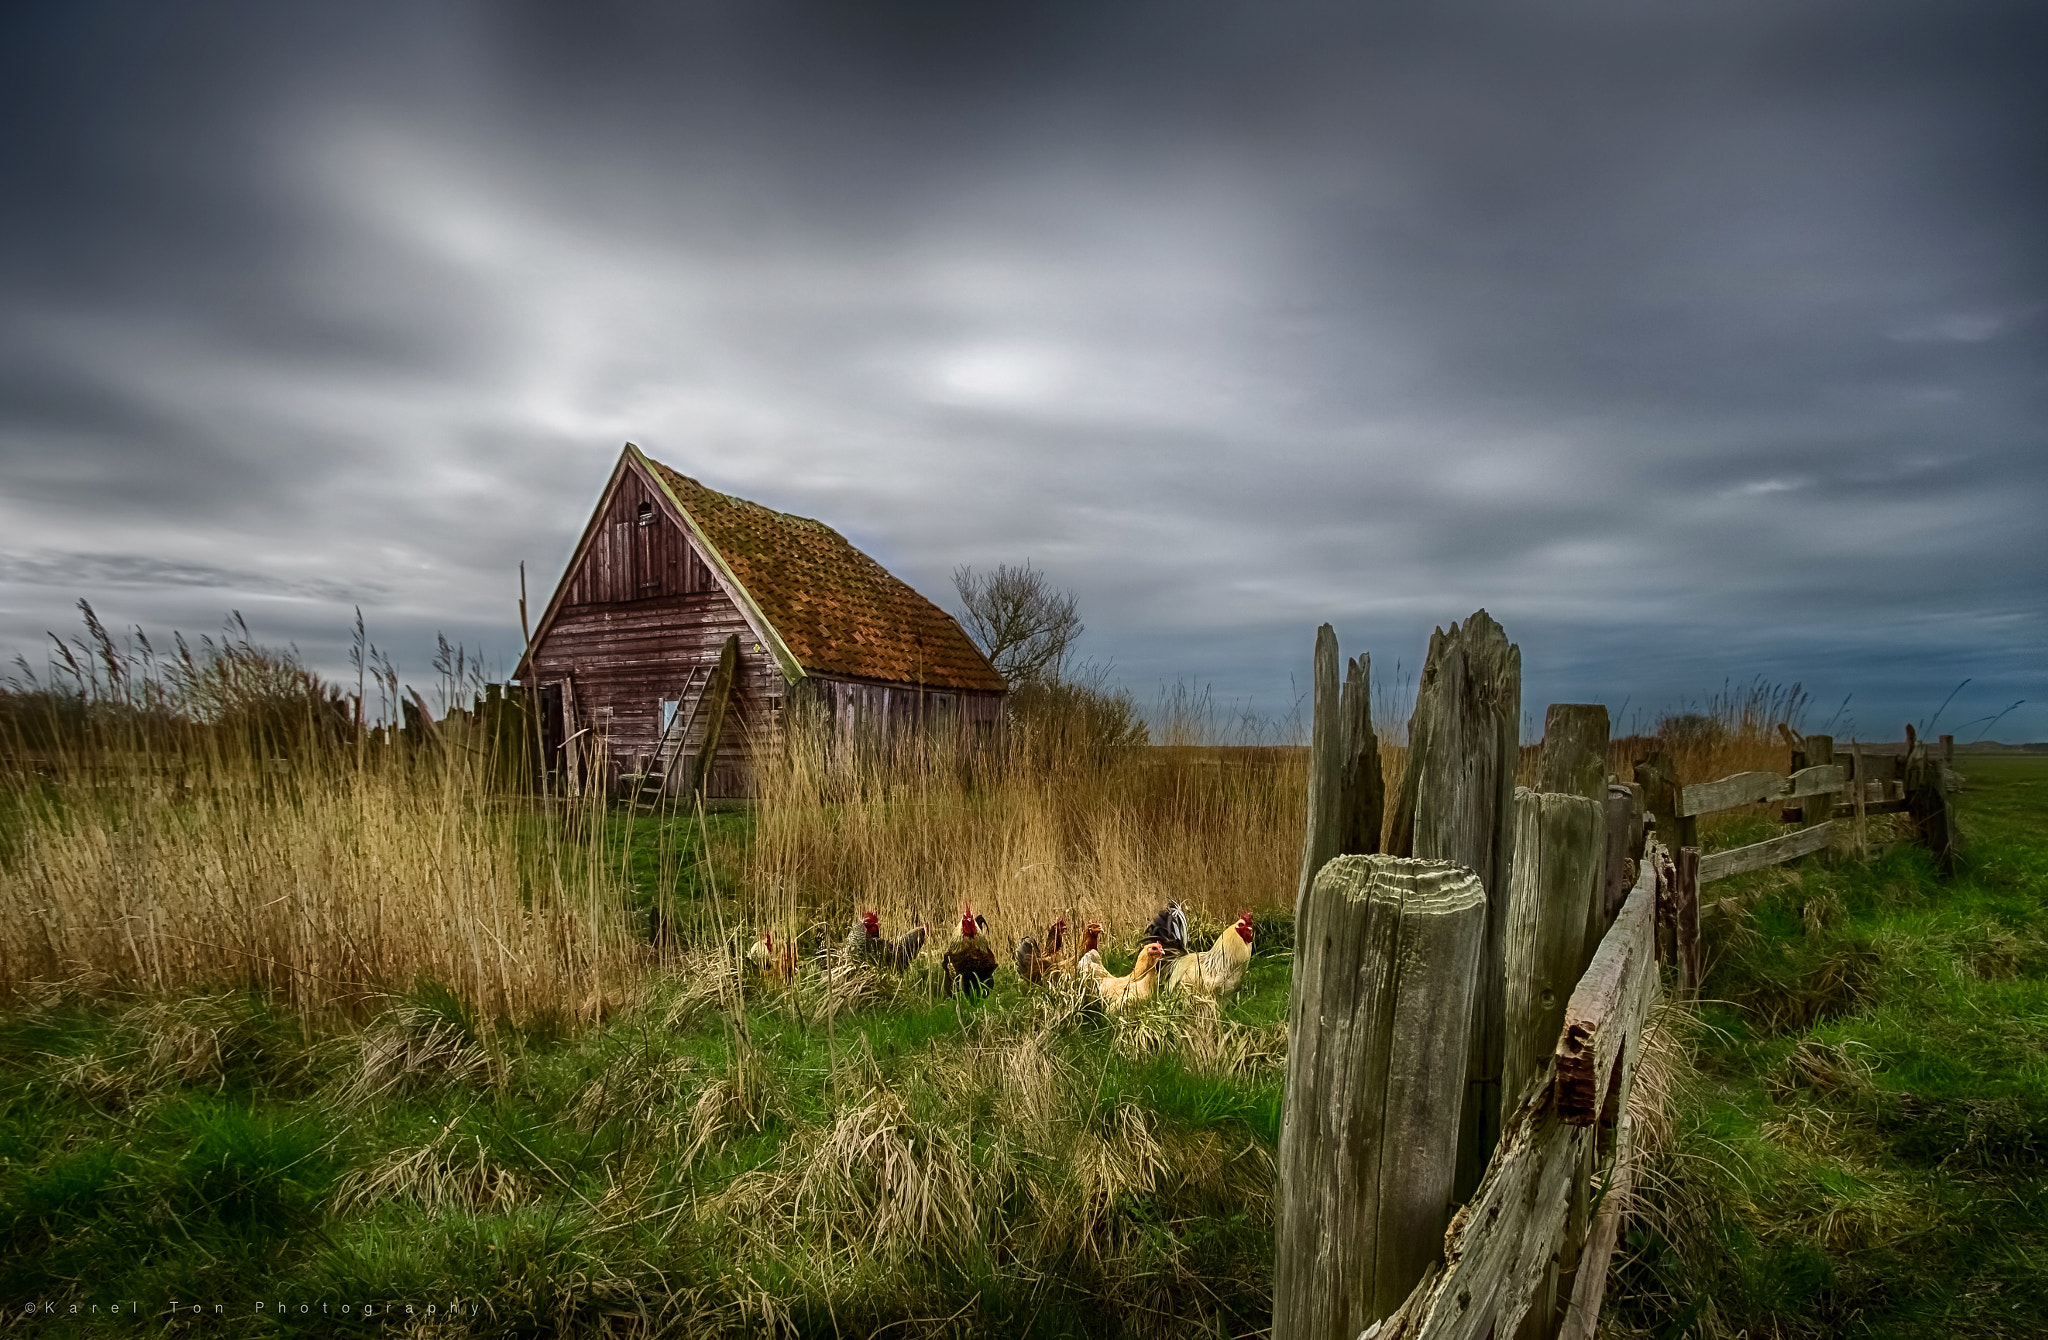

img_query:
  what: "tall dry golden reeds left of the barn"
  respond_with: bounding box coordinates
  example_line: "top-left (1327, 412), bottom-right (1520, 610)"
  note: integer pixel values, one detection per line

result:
top-left (0, 622), bottom-right (631, 1018)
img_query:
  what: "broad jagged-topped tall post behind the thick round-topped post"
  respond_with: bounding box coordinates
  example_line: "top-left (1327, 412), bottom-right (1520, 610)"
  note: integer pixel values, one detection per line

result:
top-left (1389, 611), bottom-right (1522, 1197)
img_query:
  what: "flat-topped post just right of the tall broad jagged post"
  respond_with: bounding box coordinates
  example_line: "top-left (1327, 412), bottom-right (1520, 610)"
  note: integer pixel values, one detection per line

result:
top-left (1501, 789), bottom-right (1606, 1104)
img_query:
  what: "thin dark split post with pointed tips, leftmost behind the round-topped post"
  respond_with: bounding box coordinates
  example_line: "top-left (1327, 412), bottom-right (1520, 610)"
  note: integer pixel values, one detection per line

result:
top-left (1294, 623), bottom-right (1386, 906)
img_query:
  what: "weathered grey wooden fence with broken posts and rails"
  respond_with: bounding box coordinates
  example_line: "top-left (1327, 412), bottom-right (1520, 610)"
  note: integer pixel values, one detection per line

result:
top-left (1272, 613), bottom-right (1954, 1340)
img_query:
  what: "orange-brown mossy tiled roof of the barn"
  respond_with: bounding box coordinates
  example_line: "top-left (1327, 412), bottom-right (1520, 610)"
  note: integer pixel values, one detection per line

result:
top-left (647, 459), bottom-right (1008, 693)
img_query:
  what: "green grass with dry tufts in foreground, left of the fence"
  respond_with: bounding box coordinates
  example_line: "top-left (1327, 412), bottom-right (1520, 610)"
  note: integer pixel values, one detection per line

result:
top-left (0, 916), bottom-right (1290, 1336)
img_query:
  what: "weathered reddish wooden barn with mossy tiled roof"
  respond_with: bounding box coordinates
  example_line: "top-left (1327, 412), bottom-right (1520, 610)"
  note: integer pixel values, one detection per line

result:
top-left (516, 443), bottom-right (1008, 797)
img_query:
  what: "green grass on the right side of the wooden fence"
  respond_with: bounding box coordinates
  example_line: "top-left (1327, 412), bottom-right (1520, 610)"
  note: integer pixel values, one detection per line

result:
top-left (1608, 756), bottom-right (2048, 1336)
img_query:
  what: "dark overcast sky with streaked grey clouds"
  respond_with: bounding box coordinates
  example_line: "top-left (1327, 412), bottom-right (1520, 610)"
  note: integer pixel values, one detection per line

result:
top-left (0, 0), bottom-right (2048, 740)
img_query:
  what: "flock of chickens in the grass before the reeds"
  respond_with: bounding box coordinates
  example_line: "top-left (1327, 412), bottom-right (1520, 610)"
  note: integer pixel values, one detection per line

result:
top-left (748, 902), bottom-right (1251, 1014)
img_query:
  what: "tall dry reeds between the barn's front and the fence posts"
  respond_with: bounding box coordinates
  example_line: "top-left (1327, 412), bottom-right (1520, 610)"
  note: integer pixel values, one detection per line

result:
top-left (743, 692), bottom-right (1307, 945)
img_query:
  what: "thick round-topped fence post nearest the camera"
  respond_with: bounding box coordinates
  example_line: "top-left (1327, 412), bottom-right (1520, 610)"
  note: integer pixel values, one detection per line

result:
top-left (1272, 854), bottom-right (1487, 1340)
